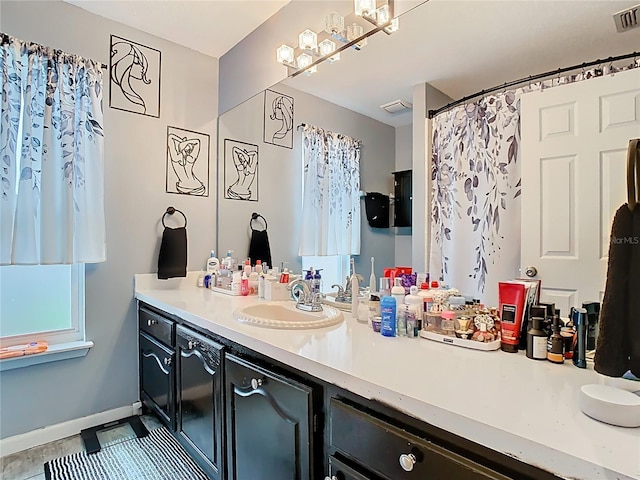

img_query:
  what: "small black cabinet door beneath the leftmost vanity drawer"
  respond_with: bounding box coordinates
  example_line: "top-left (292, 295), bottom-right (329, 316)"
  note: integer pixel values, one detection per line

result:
top-left (139, 333), bottom-right (175, 430)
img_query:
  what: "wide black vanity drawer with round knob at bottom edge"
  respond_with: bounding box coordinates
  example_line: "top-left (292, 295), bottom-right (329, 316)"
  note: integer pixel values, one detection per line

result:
top-left (330, 398), bottom-right (509, 480)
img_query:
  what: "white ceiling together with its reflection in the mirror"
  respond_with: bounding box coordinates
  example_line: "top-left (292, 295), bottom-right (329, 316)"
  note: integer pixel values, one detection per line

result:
top-left (62, 0), bottom-right (640, 126)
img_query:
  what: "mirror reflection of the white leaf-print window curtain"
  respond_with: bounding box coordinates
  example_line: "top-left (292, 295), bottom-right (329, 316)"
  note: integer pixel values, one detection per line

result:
top-left (298, 125), bottom-right (360, 256)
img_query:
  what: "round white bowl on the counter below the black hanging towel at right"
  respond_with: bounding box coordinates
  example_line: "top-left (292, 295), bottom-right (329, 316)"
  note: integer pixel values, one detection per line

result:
top-left (580, 384), bottom-right (640, 427)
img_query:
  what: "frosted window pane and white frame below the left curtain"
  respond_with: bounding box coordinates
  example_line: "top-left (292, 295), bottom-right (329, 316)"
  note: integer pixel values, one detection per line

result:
top-left (0, 264), bottom-right (85, 347)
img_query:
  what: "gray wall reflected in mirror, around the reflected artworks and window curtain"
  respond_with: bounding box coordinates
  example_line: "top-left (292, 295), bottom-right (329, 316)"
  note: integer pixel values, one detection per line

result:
top-left (218, 85), bottom-right (395, 279)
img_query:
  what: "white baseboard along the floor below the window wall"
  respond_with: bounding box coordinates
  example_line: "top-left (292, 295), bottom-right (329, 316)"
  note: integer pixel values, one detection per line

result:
top-left (0, 402), bottom-right (140, 457)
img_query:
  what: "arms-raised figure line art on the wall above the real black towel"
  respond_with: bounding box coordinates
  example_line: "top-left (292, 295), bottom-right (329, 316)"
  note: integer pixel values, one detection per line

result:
top-left (167, 127), bottom-right (209, 197)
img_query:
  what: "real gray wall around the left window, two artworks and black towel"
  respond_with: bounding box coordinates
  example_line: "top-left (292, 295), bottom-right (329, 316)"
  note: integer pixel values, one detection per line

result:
top-left (0, 0), bottom-right (218, 438)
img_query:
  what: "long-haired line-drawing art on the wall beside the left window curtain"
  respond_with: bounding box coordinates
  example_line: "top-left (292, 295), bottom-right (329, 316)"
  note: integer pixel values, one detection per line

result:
top-left (109, 35), bottom-right (160, 117)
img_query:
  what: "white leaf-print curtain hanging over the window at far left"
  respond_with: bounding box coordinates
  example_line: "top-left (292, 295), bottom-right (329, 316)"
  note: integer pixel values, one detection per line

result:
top-left (0, 35), bottom-right (106, 265)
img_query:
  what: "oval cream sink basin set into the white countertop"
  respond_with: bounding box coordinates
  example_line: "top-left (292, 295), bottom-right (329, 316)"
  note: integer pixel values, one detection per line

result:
top-left (233, 301), bottom-right (344, 329)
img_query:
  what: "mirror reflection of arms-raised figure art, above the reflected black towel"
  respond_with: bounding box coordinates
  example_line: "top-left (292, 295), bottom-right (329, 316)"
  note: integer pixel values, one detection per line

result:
top-left (224, 138), bottom-right (258, 202)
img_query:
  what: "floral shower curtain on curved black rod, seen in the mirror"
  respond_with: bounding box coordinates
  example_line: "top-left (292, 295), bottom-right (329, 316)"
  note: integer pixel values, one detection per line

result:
top-left (430, 59), bottom-right (640, 305)
